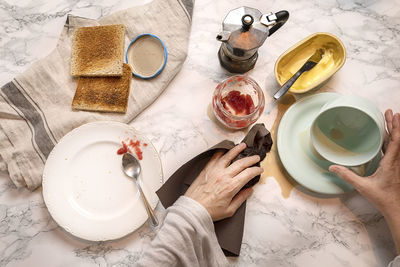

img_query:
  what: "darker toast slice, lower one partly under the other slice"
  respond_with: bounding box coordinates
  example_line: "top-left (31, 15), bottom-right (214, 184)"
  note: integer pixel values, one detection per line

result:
top-left (72, 64), bottom-right (132, 113)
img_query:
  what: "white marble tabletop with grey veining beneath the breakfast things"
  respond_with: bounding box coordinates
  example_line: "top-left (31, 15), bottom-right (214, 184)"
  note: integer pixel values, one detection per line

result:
top-left (0, 0), bottom-right (400, 267)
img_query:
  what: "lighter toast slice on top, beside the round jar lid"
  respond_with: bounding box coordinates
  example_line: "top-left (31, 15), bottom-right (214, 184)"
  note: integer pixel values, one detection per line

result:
top-left (71, 24), bottom-right (125, 76)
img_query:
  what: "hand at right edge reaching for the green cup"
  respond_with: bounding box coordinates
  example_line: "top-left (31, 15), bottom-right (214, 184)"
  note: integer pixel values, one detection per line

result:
top-left (329, 110), bottom-right (400, 252)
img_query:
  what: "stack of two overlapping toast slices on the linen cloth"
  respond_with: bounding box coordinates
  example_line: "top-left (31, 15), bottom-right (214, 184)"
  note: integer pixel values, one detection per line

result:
top-left (71, 25), bottom-right (132, 113)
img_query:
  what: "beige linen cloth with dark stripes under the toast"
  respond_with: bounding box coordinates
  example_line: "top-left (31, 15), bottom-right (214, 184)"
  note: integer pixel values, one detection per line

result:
top-left (0, 0), bottom-right (194, 190)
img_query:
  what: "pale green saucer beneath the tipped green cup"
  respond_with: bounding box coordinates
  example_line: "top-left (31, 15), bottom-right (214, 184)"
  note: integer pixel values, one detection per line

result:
top-left (277, 93), bottom-right (353, 195)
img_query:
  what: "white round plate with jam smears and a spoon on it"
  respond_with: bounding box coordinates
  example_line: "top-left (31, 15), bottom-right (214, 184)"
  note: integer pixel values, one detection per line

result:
top-left (42, 121), bottom-right (163, 241)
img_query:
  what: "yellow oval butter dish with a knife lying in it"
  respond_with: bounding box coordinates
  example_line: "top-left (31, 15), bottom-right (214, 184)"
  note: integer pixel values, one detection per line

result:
top-left (275, 32), bottom-right (346, 93)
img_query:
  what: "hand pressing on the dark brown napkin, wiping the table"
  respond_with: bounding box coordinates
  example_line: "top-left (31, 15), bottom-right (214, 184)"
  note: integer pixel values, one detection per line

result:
top-left (185, 143), bottom-right (263, 221)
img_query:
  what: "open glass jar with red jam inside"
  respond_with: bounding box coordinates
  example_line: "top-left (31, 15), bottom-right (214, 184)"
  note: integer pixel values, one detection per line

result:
top-left (212, 75), bottom-right (265, 129)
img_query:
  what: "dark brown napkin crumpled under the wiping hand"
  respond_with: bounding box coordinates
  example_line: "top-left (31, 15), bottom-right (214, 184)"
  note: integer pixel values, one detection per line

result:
top-left (156, 123), bottom-right (272, 257)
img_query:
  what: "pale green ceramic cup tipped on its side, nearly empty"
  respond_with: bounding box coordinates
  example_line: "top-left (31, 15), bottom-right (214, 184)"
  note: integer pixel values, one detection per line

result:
top-left (310, 95), bottom-right (385, 175)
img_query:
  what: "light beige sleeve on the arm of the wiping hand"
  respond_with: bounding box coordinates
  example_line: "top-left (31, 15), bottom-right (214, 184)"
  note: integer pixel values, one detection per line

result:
top-left (136, 196), bottom-right (228, 266)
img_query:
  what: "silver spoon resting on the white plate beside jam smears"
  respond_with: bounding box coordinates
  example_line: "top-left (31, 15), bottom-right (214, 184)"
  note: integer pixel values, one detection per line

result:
top-left (122, 153), bottom-right (158, 227)
